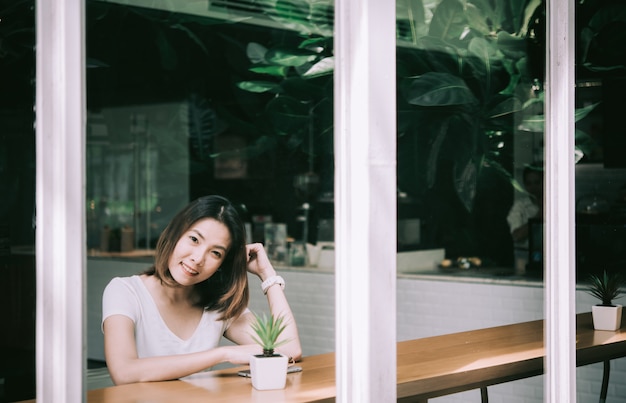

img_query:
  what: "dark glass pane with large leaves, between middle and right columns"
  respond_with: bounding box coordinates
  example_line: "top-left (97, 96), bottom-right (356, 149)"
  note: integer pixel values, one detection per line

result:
top-left (397, 0), bottom-right (543, 276)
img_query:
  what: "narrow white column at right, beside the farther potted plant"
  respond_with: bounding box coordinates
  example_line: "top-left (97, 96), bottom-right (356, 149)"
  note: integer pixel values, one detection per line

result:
top-left (544, 0), bottom-right (576, 403)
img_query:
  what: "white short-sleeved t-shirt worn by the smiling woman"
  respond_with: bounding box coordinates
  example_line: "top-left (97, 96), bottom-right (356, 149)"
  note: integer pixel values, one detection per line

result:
top-left (102, 275), bottom-right (243, 358)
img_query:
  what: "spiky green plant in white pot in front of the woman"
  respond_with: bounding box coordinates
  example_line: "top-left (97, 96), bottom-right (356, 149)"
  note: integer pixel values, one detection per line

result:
top-left (250, 314), bottom-right (288, 390)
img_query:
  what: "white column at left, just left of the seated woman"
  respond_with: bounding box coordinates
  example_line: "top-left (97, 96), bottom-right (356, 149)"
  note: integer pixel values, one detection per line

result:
top-left (35, 0), bottom-right (86, 403)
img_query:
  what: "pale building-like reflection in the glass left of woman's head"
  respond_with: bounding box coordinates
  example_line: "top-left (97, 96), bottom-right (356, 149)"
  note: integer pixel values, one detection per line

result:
top-left (87, 102), bottom-right (189, 252)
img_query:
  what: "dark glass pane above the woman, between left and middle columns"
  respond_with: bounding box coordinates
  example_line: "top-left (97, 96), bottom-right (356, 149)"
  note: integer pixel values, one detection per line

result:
top-left (87, 1), bottom-right (333, 259)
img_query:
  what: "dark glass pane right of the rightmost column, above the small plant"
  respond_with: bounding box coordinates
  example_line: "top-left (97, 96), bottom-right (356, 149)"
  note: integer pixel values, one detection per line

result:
top-left (576, 1), bottom-right (626, 281)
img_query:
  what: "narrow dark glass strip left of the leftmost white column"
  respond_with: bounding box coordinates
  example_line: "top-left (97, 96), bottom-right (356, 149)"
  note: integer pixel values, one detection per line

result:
top-left (0, 0), bottom-right (36, 402)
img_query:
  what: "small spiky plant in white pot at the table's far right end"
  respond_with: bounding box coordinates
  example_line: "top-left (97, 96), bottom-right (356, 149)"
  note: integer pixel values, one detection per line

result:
top-left (587, 270), bottom-right (624, 331)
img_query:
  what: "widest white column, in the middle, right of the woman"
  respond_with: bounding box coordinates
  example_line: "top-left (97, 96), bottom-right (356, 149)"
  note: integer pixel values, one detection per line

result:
top-left (334, 0), bottom-right (396, 403)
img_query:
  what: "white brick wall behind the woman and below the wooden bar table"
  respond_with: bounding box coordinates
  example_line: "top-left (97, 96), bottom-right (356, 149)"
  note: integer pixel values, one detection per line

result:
top-left (87, 260), bottom-right (626, 403)
